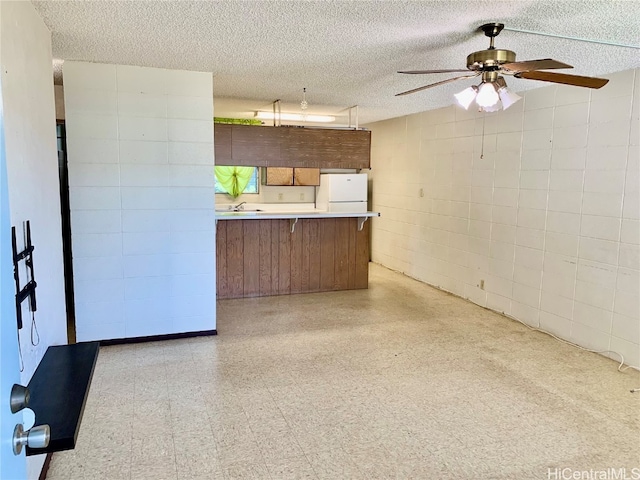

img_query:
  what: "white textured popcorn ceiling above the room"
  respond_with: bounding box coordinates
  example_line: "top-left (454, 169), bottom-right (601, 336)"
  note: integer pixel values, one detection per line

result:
top-left (33, 0), bottom-right (640, 124)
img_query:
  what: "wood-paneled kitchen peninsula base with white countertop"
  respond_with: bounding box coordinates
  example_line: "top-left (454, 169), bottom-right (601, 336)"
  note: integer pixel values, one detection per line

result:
top-left (216, 211), bottom-right (379, 299)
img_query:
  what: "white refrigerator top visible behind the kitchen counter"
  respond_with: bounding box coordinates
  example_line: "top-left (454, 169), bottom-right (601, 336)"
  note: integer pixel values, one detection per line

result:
top-left (316, 173), bottom-right (368, 213)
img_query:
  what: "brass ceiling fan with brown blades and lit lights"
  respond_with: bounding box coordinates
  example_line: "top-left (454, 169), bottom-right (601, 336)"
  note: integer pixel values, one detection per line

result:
top-left (396, 23), bottom-right (609, 112)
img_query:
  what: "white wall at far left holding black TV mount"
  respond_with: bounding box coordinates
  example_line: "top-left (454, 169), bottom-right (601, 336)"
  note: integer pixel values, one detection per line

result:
top-left (0, 2), bottom-right (67, 478)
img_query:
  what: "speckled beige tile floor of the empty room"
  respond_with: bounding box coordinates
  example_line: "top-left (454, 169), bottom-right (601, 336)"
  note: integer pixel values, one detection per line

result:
top-left (47, 265), bottom-right (640, 480)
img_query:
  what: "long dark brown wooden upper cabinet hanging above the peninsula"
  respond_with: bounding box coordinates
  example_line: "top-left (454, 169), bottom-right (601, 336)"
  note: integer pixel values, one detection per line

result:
top-left (214, 124), bottom-right (371, 169)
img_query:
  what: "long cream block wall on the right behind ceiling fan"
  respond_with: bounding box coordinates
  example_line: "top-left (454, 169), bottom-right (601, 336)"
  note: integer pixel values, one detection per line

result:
top-left (370, 69), bottom-right (640, 366)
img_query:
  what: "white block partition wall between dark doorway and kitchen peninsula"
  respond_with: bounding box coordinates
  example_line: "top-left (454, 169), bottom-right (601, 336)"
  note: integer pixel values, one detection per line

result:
top-left (64, 62), bottom-right (216, 341)
